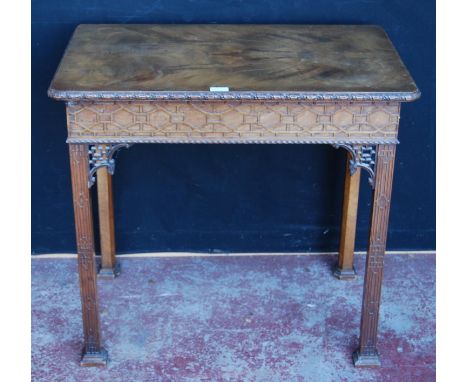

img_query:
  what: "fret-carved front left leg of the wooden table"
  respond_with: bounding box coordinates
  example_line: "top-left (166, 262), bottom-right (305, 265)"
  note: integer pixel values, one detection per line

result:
top-left (69, 144), bottom-right (107, 366)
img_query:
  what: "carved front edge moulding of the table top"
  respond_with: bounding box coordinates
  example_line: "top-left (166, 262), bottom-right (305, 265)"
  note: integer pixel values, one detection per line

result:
top-left (47, 88), bottom-right (421, 102)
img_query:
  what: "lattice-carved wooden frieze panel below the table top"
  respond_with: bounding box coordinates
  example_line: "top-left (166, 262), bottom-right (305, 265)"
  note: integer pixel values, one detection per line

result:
top-left (67, 101), bottom-right (400, 143)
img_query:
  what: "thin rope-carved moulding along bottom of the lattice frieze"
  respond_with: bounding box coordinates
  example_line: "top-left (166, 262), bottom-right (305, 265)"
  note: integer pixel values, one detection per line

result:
top-left (66, 137), bottom-right (400, 145)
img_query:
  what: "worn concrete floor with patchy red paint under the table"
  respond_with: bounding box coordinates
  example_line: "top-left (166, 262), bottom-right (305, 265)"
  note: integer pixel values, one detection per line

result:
top-left (32, 255), bottom-right (435, 382)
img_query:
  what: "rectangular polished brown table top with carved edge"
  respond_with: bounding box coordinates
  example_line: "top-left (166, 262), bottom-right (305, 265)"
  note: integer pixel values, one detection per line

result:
top-left (49, 24), bottom-right (419, 101)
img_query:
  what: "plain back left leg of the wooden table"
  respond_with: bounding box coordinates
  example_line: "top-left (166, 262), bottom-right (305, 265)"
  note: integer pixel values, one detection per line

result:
top-left (97, 167), bottom-right (120, 279)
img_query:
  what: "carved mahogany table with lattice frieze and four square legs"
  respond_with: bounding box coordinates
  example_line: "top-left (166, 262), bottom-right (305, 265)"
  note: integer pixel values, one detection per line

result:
top-left (49, 25), bottom-right (420, 366)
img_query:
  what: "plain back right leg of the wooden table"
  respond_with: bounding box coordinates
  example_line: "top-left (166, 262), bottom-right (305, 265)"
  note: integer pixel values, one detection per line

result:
top-left (334, 153), bottom-right (361, 280)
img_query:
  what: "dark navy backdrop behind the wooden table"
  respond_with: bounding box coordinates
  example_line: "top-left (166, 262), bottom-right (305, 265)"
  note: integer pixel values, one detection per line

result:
top-left (32, 0), bottom-right (435, 254)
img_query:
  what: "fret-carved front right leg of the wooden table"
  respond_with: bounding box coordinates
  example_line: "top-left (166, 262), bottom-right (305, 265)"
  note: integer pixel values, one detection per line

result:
top-left (353, 145), bottom-right (396, 366)
